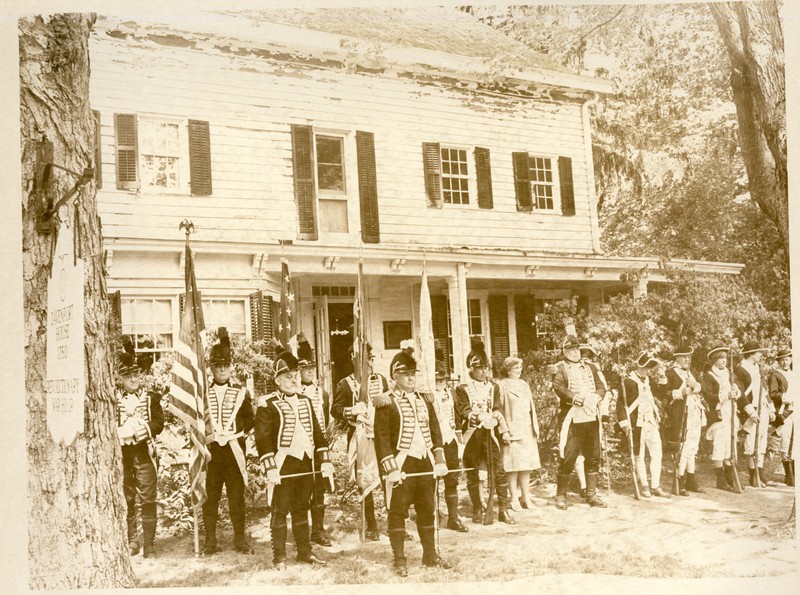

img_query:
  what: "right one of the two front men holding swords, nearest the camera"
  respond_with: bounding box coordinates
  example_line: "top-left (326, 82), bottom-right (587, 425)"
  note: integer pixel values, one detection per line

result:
top-left (375, 352), bottom-right (451, 576)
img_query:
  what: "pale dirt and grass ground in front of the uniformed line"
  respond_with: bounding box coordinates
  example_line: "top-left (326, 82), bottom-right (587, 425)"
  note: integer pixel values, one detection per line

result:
top-left (133, 468), bottom-right (800, 592)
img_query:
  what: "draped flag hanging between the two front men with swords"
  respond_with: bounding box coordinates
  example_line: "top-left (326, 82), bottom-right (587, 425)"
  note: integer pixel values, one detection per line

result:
top-left (347, 262), bottom-right (380, 500)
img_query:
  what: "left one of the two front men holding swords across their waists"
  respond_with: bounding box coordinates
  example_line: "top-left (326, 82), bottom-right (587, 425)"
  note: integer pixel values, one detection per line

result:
top-left (255, 351), bottom-right (333, 570)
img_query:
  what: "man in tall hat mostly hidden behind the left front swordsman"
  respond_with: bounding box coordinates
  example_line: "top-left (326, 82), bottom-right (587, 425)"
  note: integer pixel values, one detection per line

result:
top-left (297, 334), bottom-right (331, 547)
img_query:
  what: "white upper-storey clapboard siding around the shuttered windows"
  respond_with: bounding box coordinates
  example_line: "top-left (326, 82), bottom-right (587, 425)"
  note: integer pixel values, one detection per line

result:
top-left (90, 31), bottom-right (593, 253)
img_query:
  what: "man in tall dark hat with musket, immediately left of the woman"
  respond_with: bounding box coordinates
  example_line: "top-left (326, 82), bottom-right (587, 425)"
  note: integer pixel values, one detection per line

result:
top-left (455, 340), bottom-right (516, 525)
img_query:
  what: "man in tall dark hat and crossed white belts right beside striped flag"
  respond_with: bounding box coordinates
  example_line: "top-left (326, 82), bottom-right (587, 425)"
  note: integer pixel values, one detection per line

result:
top-left (203, 326), bottom-right (253, 556)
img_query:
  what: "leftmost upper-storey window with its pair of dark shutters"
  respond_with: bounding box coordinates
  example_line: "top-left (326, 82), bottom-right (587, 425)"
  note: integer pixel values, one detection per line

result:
top-left (113, 114), bottom-right (211, 196)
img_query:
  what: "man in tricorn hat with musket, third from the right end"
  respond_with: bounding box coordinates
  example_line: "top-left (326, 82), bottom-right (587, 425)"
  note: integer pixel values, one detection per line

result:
top-left (702, 346), bottom-right (739, 491)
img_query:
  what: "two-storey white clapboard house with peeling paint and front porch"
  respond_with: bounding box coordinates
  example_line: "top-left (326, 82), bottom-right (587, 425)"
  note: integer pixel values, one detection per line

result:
top-left (90, 8), bottom-right (741, 386)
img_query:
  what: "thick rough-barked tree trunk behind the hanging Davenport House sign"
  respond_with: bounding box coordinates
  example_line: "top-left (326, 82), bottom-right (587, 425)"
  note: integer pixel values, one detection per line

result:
top-left (19, 15), bottom-right (133, 589)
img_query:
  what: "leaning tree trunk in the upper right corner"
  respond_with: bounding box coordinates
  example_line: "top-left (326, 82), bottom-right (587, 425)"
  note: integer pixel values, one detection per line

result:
top-left (709, 2), bottom-right (789, 255)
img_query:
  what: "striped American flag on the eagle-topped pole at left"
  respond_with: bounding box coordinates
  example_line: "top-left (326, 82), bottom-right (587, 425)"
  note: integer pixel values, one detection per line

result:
top-left (168, 239), bottom-right (211, 510)
